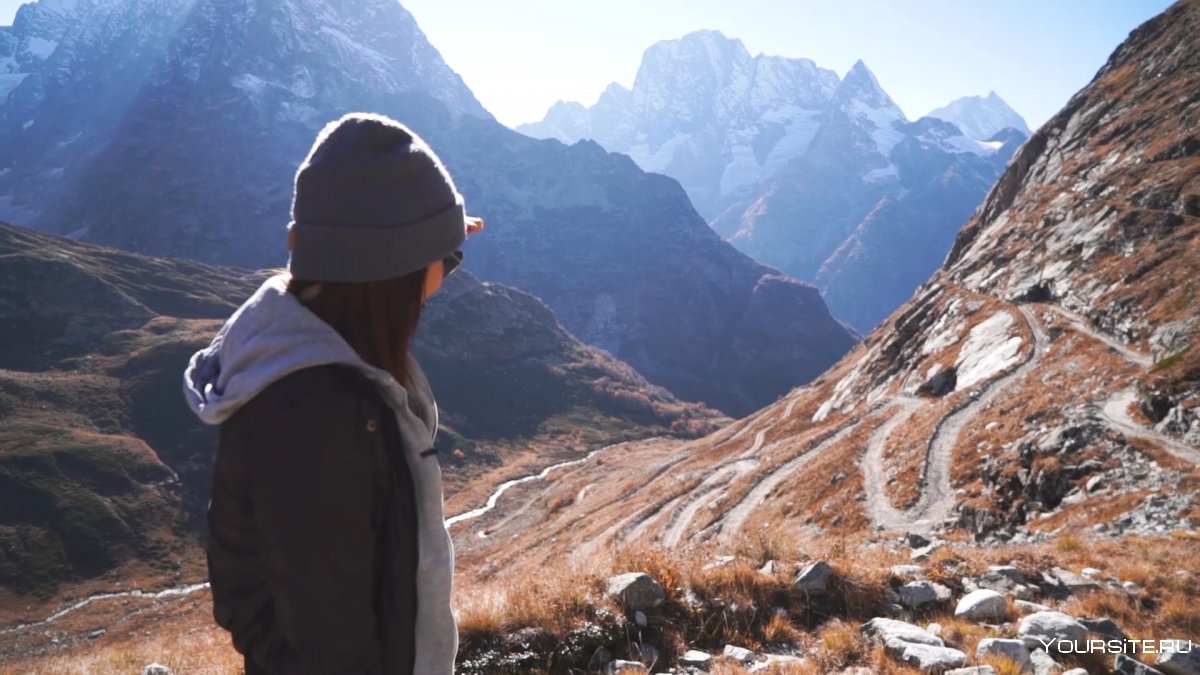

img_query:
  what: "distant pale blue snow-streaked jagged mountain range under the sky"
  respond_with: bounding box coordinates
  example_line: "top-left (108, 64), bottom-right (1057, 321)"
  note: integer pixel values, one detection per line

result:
top-left (517, 31), bottom-right (1028, 331)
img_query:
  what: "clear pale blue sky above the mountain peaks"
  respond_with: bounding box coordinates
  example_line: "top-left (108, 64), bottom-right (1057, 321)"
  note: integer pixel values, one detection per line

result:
top-left (0, 0), bottom-right (1170, 127)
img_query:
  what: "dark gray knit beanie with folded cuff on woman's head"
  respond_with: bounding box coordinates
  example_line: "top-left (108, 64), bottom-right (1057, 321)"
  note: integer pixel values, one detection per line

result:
top-left (288, 113), bottom-right (467, 281)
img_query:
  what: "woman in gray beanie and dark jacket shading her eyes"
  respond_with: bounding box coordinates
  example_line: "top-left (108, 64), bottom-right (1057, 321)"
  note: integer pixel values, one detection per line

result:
top-left (184, 114), bottom-right (482, 675)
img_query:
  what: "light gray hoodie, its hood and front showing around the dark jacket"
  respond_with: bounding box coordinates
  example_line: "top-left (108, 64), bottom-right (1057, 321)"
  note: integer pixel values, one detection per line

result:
top-left (184, 274), bottom-right (458, 675)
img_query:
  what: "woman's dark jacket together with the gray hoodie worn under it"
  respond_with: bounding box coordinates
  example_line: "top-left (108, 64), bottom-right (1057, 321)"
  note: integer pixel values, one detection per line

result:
top-left (184, 275), bottom-right (458, 675)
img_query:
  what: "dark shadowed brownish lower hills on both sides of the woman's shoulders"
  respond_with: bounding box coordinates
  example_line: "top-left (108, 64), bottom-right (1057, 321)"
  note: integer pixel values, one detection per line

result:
top-left (0, 219), bottom-right (718, 598)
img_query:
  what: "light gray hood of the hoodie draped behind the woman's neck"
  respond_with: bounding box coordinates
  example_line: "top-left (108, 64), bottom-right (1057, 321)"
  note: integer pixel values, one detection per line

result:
top-left (184, 274), bottom-right (437, 437)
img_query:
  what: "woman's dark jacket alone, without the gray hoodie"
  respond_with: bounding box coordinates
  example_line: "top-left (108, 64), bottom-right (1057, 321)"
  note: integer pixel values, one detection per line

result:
top-left (208, 365), bottom-right (418, 674)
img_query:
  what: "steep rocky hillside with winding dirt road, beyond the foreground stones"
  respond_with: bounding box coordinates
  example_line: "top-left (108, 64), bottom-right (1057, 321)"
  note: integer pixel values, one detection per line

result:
top-left (444, 0), bottom-right (1200, 567)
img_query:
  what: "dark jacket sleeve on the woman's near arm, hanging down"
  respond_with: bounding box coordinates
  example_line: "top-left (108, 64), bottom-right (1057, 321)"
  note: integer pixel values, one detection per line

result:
top-left (234, 369), bottom-right (382, 674)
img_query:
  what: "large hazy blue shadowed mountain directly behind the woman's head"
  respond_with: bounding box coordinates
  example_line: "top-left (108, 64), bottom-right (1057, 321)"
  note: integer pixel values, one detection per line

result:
top-left (0, 0), bottom-right (857, 414)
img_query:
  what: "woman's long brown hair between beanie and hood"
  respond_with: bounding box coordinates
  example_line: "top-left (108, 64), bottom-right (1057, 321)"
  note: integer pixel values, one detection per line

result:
top-left (288, 269), bottom-right (425, 387)
